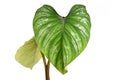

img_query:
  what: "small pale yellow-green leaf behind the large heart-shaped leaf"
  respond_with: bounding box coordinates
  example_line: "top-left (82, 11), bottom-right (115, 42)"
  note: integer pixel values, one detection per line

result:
top-left (15, 38), bottom-right (41, 69)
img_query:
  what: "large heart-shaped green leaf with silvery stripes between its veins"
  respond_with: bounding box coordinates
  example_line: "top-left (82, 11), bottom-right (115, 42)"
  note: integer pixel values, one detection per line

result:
top-left (33, 5), bottom-right (91, 74)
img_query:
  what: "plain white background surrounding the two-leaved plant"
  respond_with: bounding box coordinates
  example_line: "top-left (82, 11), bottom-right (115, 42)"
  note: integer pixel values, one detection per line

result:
top-left (0, 0), bottom-right (120, 80)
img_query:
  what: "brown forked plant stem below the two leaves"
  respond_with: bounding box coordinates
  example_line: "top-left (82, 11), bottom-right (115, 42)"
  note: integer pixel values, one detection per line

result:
top-left (41, 53), bottom-right (50, 80)
